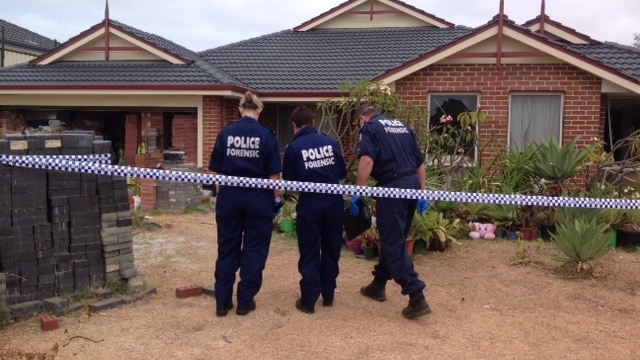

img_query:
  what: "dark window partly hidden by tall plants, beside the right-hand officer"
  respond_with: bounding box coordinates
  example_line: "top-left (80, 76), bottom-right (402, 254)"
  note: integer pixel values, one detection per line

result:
top-left (429, 94), bottom-right (479, 159)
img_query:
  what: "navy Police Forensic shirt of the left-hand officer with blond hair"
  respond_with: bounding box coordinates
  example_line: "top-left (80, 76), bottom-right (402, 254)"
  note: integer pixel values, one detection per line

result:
top-left (209, 116), bottom-right (282, 179)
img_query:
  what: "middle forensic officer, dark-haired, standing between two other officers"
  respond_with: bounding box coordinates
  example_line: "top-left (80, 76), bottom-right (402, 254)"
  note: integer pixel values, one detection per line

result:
top-left (282, 106), bottom-right (347, 314)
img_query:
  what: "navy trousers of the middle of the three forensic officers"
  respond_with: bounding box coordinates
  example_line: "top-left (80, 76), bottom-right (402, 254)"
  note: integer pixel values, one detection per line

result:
top-left (296, 194), bottom-right (344, 309)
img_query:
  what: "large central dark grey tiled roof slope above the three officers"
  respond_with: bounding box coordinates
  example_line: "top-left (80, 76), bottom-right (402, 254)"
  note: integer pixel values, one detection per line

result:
top-left (200, 27), bottom-right (472, 92)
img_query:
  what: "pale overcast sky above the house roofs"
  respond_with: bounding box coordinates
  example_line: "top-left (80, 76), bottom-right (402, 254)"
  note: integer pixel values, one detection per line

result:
top-left (0, 0), bottom-right (640, 51)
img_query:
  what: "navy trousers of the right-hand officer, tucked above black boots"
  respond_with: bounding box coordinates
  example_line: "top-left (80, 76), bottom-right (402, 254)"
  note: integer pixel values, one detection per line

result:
top-left (373, 175), bottom-right (426, 295)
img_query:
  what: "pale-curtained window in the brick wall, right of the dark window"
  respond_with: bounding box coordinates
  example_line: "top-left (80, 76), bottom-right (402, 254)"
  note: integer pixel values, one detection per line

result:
top-left (509, 94), bottom-right (563, 149)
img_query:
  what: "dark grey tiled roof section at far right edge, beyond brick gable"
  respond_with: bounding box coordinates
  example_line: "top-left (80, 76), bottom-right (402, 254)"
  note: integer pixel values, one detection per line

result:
top-left (563, 43), bottom-right (640, 80)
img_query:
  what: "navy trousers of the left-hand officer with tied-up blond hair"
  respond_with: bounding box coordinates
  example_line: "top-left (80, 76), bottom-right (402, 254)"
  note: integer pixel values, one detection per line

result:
top-left (214, 186), bottom-right (274, 305)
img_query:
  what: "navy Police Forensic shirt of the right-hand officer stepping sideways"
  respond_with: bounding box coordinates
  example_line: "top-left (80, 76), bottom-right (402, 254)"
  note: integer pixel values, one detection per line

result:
top-left (358, 114), bottom-right (424, 183)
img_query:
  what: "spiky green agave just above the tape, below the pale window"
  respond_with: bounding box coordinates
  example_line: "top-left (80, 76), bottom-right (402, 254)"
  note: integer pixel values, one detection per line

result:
top-left (525, 137), bottom-right (589, 193)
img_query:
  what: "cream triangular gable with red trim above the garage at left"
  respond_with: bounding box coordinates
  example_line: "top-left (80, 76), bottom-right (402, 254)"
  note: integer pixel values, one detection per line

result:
top-left (31, 19), bottom-right (190, 65)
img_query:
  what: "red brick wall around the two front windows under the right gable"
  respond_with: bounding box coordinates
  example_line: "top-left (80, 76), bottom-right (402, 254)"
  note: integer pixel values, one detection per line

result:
top-left (396, 64), bottom-right (604, 159)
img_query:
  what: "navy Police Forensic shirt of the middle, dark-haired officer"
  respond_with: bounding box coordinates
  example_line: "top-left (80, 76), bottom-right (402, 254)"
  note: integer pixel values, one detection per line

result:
top-left (282, 126), bottom-right (347, 191)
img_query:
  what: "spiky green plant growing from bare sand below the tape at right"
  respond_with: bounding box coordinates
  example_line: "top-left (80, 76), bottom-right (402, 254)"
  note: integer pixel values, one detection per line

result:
top-left (551, 208), bottom-right (611, 273)
